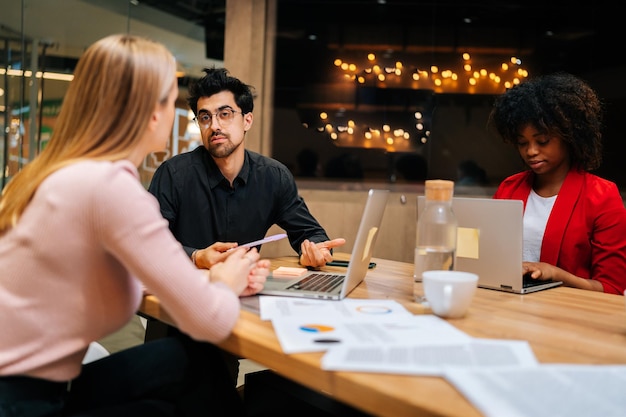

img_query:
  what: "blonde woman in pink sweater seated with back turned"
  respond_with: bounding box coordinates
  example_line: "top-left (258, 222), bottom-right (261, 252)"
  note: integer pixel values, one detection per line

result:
top-left (0, 35), bottom-right (270, 417)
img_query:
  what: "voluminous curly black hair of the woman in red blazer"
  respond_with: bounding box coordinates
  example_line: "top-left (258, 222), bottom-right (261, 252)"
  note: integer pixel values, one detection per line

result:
top-left (489, 73), bottom-right (604, 171)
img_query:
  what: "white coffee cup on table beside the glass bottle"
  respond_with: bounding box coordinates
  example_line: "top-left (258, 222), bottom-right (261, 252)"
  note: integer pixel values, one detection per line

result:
top-left (422, 270), bottom-right (478, 318)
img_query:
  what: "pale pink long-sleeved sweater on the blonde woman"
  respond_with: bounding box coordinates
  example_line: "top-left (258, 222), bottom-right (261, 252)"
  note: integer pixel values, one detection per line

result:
top-left (0, 161), bottom-right (240, 381)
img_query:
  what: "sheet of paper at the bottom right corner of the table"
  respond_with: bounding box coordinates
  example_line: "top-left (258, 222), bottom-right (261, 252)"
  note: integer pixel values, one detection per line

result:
top-left (444, 364), bottom-right (626, 417)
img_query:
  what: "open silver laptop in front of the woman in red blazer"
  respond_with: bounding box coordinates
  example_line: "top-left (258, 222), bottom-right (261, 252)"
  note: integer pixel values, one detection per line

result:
top-left (417, 196), bottom-right (562, 294)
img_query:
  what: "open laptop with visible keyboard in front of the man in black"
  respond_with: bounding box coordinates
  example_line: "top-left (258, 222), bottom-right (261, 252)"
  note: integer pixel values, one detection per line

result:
top-left (259, 189), bottom-right (389, 300)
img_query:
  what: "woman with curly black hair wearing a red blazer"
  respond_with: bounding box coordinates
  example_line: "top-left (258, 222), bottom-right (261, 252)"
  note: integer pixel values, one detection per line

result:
top-left (489, 73), bottom-right (626, 294)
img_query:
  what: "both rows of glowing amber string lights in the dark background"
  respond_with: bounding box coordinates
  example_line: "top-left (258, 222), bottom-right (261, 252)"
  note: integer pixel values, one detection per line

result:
top-left (299, 53), bottom-right (528, 152)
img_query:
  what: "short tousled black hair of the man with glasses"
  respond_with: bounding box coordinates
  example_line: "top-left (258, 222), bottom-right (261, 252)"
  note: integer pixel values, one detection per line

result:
top-left (187, 67), bottom-right (254, 116)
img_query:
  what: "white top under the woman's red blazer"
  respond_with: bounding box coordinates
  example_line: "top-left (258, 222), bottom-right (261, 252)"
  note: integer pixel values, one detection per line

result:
top-left (522, 190), bottom-right (556, 262)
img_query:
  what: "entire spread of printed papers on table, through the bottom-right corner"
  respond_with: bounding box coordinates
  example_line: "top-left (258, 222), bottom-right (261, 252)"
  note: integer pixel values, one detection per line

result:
top-left (259, 296), bottom-right (626, 417)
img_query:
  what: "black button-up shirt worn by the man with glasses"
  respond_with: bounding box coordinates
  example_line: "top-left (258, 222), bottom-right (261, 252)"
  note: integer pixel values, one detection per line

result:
top-left (148, 146), bottom-right (329, 255)
